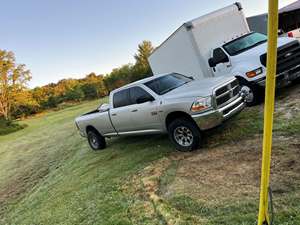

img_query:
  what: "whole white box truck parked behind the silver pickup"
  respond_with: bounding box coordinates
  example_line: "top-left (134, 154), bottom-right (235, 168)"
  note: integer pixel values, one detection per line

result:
top-left (149, 3), bottom-right (300, 105)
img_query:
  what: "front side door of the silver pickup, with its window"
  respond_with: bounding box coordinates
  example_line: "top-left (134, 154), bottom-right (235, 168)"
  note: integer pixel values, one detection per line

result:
top-left (129, 86), bottom-right (163, 132)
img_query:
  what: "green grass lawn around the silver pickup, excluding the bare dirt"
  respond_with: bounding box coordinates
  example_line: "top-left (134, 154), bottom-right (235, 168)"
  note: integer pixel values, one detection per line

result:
top-left (0, 85), bottom-right (300, 225)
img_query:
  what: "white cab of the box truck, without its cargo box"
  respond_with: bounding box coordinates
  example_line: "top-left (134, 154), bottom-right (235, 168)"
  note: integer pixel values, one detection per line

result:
top-left (208, 32), bottom-right (300, 105)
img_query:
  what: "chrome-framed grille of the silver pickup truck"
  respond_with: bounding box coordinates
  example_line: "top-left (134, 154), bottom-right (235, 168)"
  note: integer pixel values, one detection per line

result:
top-left (215, 79), bottom-right (240, 108)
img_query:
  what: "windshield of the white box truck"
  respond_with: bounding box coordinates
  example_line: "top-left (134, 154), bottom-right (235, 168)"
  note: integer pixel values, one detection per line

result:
top-left (223, 33), bottom-right (267, 56)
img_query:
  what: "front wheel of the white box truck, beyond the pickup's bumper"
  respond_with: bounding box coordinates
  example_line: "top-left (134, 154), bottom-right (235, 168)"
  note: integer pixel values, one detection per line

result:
top-left (240, 82), bottom-right (263, 106)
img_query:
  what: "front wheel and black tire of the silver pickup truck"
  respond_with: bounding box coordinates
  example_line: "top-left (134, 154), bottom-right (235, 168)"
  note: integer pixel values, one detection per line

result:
top-left (168, 118), bottom-right (202, 152)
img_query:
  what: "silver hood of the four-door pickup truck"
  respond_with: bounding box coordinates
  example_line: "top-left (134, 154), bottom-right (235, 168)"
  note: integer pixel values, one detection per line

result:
top-left (163, 76), bottom-right (233, 99)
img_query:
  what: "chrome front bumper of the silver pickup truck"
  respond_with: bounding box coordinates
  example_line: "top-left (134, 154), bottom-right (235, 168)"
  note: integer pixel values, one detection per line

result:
top-left (192, 96), bottom-right (245, 130)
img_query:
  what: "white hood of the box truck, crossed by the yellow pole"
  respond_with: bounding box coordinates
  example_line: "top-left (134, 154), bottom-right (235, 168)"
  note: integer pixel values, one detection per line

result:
top-left (232, 37), bottom-right (295, 59)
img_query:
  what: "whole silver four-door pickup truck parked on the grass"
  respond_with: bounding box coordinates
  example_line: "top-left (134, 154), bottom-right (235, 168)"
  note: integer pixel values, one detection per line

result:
top-left (75, 73), bottom-right (245, 151)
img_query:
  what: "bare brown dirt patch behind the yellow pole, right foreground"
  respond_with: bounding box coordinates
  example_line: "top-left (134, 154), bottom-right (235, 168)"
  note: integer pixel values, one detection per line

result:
top-left (163, 137), bottom-right (300, 202)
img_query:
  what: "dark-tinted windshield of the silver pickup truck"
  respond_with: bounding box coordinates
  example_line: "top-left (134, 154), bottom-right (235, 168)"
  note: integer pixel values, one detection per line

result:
top-left (145, 73), bottom-right (193, 95)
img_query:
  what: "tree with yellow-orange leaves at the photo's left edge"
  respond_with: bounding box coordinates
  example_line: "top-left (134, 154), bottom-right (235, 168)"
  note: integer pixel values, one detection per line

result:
top-left (0, 50), bottom-right (31, 120)
